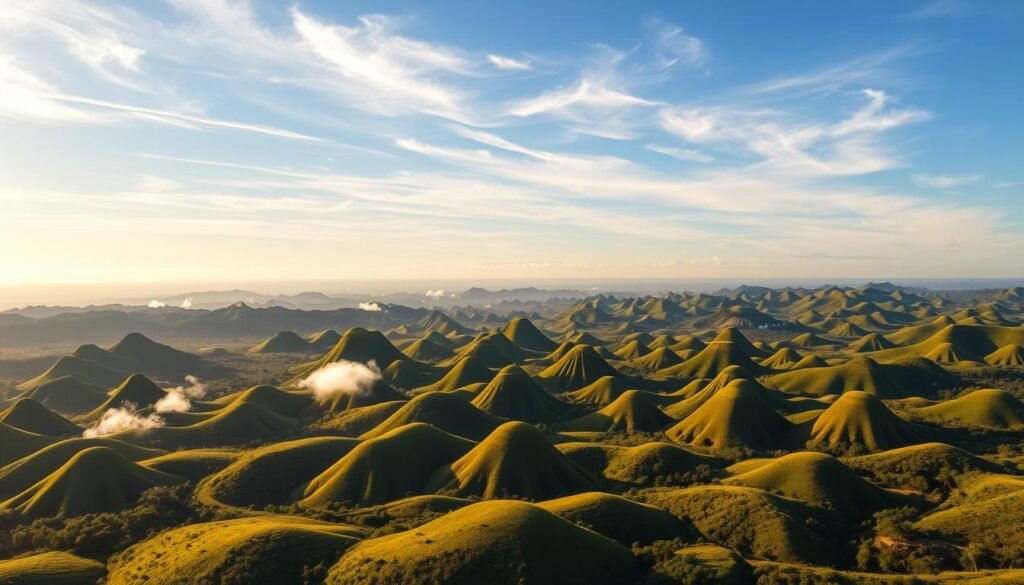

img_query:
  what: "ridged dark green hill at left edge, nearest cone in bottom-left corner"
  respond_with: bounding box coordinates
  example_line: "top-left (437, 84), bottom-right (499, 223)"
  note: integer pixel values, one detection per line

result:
top-left (0, 447), bottom-right (182, 516)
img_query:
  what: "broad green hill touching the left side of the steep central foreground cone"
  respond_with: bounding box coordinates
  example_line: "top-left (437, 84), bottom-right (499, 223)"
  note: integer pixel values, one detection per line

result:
top-left (301, 423), bottom-right (473, 506)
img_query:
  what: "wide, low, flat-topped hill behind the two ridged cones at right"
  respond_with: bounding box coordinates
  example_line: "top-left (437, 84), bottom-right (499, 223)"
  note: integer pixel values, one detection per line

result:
top-left (765, 357), bottom-right (956, 399)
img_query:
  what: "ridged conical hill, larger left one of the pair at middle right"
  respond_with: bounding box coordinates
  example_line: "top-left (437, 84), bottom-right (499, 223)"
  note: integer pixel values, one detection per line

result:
top-left (666, 379), bottom-right (792, 450)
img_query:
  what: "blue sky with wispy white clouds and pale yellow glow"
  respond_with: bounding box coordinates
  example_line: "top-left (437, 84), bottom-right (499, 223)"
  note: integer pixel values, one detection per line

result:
top-left (0, 0), bottom-right (1024, 286)
